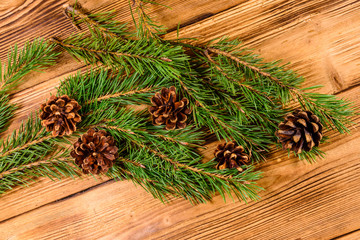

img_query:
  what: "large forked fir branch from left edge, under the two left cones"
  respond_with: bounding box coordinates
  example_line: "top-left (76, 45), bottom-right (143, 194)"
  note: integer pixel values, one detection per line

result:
top-left (0, 69), bottom-right (261, 203)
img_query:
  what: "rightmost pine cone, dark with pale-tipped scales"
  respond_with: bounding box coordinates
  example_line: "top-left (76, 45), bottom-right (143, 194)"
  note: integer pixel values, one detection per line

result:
top-left (276, 110), bottom-right (323, 153)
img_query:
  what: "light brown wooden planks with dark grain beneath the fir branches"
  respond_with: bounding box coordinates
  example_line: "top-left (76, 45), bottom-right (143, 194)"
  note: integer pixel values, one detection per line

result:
top-left (0, 0), bottom-right (360, 240)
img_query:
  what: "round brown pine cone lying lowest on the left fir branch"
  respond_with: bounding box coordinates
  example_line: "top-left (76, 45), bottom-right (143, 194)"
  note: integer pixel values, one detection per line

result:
top-left (70, 128), bottom-right (119, 174)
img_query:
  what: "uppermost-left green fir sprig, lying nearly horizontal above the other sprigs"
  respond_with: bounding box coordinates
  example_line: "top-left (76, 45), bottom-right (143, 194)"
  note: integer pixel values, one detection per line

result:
top-left (52, 34), bottom-right (188, 78)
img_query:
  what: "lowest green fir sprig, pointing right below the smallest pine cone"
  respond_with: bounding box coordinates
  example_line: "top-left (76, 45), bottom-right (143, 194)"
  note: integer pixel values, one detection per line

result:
top-left (104, 123), bottom-right (259, 203)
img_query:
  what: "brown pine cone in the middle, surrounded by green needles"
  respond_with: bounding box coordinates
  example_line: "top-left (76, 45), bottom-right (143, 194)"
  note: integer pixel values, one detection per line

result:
top-left (149, 87), bottom-right (191, 130)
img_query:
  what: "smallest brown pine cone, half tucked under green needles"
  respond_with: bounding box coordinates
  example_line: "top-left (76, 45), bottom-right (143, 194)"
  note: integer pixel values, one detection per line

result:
top-left (214, 142), bottom-right (250, 172)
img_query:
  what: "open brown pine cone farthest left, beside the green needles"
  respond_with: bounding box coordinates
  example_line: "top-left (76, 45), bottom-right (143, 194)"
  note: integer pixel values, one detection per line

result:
top-left (40, 95), bottom-right (81, 137)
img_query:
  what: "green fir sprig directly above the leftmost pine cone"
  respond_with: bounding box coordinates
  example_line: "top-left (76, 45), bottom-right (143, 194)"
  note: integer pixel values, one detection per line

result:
top-left (58, 69), bottom-right (164, 105)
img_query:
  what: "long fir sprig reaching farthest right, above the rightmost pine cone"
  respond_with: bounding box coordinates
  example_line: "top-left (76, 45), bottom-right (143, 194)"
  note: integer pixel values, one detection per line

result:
top-left (201, 39), bottom-right (355, 133)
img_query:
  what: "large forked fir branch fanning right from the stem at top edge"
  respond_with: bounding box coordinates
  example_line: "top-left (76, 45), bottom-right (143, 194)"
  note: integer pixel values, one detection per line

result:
top-left (55, 1), bottom-right (354, 161)
